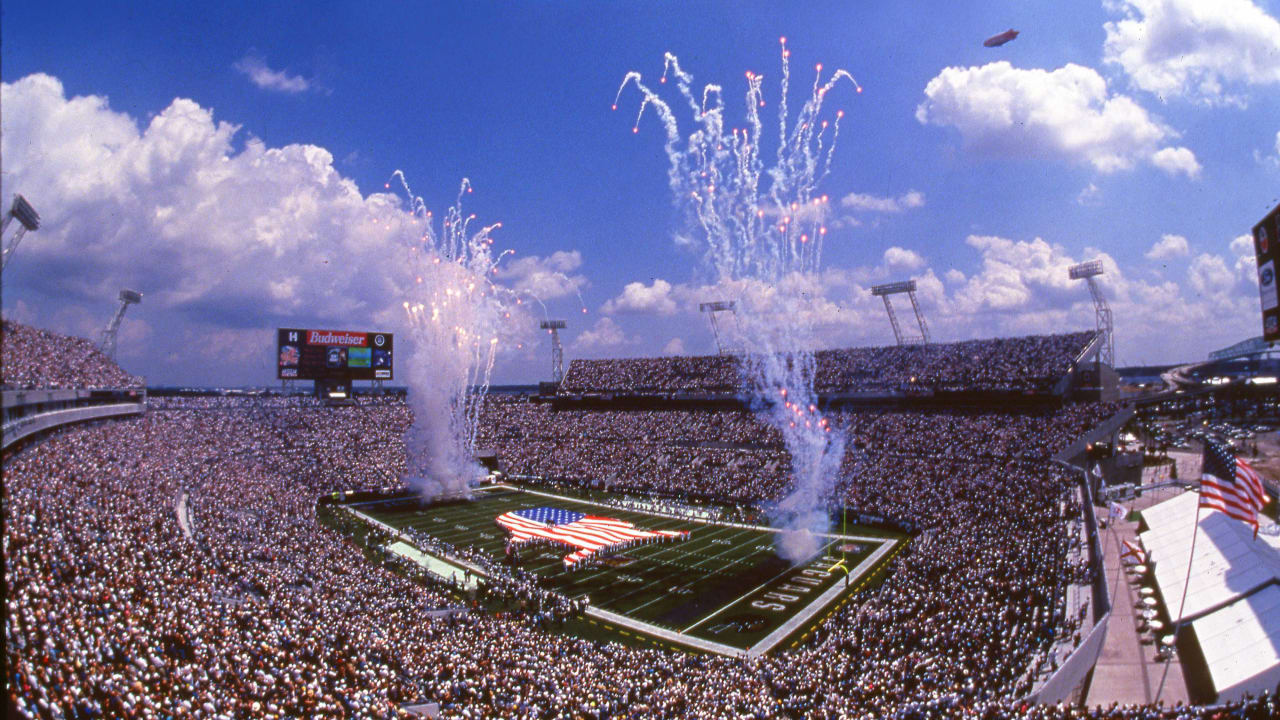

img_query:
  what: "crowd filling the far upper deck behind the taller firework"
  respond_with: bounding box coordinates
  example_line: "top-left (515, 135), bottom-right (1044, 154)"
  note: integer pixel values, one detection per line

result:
top-left (559, 332), bottom-right (1093, 395)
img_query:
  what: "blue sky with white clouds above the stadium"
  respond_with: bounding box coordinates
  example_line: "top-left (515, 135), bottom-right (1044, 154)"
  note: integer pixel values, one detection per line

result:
top-left (0, 0), bottom-right (1280, 383)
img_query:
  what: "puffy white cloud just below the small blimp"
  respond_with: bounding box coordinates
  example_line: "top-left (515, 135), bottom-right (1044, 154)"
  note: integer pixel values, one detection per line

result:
top-left (915, 60), bottom-right (1198, 173)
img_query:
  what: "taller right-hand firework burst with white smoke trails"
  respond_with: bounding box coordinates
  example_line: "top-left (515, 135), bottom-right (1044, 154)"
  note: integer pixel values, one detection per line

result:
top-left (613, 38), bottom-right (861, 562)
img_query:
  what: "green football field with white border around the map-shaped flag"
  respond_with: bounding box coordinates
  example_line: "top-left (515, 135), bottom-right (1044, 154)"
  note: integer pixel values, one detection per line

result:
top-left (349, 487), bottom-right (906, 655)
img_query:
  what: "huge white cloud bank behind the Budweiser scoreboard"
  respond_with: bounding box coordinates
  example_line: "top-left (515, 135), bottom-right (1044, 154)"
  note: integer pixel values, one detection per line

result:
top-left (0, 74), bottom-right (560, 383)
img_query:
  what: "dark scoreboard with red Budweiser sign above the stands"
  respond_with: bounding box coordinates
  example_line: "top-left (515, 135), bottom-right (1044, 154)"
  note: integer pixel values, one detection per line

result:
top-left (275, 328), bottom-right (394, 380)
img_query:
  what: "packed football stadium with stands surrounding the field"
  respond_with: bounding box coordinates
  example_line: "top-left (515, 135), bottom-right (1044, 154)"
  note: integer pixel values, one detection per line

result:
top-left (4, 311), bottom-right (1276, 717)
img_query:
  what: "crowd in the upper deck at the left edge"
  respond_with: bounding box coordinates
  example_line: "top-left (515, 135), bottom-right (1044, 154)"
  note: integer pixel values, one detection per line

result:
top-left (0, 320), bottom-right (142, 389)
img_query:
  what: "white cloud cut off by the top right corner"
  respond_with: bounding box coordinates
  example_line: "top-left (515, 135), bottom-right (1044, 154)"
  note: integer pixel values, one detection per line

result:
top-left (1103, 0), bottom-right (1280, 105)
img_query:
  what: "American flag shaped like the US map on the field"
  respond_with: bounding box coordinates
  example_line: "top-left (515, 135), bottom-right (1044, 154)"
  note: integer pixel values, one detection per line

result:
top-left (497, 506), bottom-right (689, 569)
